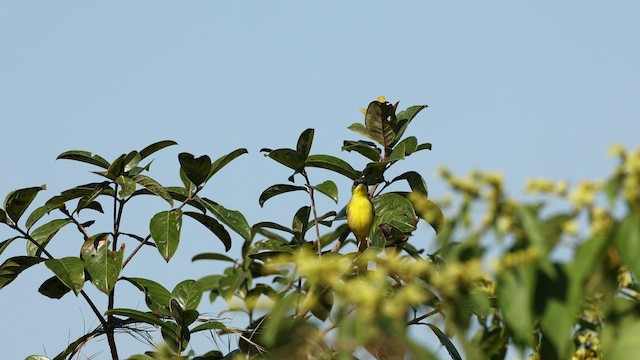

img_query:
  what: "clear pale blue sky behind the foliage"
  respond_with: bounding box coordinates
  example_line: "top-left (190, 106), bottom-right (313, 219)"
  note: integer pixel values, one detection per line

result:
top-left (0, 0), bottom-right (640, 359)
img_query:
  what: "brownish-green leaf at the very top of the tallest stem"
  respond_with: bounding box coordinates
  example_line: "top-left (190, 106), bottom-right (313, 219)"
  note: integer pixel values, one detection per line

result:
top-left (364, 101), bottom-right (398, 148)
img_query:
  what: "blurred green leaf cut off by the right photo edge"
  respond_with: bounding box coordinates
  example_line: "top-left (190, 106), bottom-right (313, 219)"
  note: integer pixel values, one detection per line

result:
top-left (615, 213), bottom-right (640, 277)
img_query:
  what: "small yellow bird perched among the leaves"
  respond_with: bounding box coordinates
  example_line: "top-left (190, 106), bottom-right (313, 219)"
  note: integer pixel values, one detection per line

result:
top-left (347, 179), bottom-right (375, 252)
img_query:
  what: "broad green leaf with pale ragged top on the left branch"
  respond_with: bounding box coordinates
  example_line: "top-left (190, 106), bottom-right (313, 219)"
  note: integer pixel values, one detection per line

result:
top-left (80, 234), bottom-right (124, 294)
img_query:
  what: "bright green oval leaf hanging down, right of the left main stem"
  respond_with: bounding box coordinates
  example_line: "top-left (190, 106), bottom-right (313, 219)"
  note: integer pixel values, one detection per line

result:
top-left (149, 209), bottom-right (182, 262)
